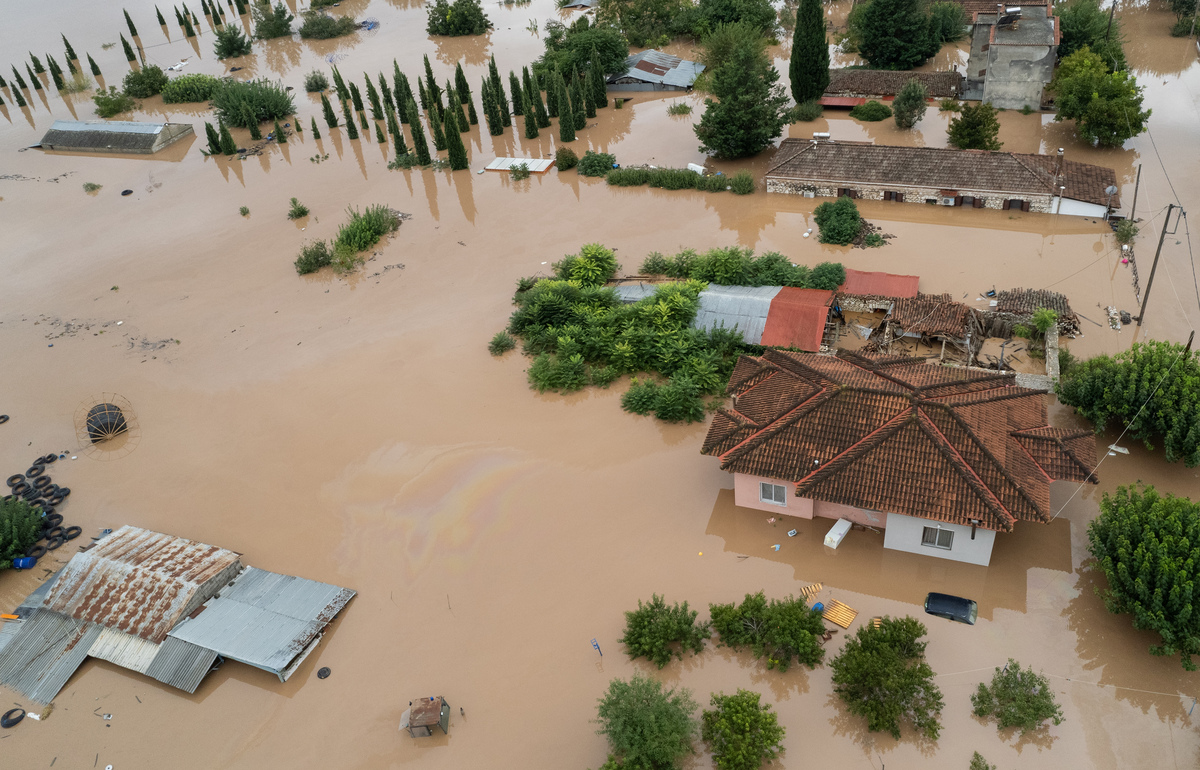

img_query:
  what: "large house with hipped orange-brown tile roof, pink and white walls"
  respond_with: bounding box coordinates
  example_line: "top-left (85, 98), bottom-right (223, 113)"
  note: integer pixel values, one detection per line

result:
top-left (701, 350), bottom-right (1096, 565)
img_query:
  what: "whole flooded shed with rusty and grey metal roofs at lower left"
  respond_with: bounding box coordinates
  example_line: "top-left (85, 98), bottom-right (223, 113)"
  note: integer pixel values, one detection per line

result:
top-left (0, 527), bottom-right (355, 703)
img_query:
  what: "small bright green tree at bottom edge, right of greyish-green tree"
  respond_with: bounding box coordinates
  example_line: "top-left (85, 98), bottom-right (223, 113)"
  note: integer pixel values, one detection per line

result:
top-left (700, 690), bottom-right (784, 770)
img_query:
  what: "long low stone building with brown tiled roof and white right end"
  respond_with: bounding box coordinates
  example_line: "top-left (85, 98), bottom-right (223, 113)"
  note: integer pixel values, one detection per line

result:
top-left (766, 139), bottom-right (1121, 217)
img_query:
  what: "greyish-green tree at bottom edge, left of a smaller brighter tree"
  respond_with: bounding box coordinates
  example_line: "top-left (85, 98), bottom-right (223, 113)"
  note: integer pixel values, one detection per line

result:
top-left (596, 675), bottom-right (698, 770)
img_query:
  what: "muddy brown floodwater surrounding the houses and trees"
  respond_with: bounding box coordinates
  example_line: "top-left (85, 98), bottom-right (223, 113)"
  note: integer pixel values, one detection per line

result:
top-left (0, 0), bottom-right (1200, 770)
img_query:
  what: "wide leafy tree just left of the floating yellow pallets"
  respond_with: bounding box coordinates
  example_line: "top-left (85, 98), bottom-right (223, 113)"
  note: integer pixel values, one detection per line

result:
top-left (709, 591), bottom-right (824, 672)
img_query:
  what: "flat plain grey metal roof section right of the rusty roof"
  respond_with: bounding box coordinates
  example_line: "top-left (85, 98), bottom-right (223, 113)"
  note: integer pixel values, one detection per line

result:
top-left (169, 567), bottom-right (355, 676)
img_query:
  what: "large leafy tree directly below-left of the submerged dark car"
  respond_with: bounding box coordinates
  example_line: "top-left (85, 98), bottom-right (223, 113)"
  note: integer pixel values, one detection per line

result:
top-left (829, 616), bottom-right (943, 740)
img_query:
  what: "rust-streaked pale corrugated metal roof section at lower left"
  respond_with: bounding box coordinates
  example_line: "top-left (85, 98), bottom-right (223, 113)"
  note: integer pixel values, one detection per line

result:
top-left (43, 527), bottom-right (241, 644)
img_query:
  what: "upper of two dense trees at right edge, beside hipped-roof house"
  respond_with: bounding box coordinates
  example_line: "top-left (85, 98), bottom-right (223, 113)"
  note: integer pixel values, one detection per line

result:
top-left (1057, 341), bottom-right (1200, 460)
